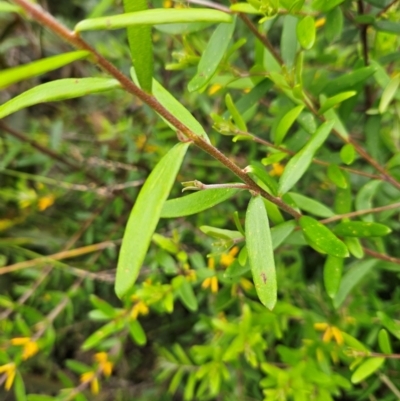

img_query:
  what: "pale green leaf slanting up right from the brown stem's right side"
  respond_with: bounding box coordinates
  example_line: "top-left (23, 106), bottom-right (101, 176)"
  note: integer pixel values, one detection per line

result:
top-left (278, 121), bottom-right (334, 195)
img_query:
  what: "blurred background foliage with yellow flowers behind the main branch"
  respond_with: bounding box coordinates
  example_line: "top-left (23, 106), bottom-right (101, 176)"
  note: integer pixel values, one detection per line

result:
top-left (0, 0), bottom-right (400, 401)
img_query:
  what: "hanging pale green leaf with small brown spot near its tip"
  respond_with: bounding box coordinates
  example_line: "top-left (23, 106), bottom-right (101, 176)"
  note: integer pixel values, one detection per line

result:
top-left (245, 196), bottom-right (277, 309)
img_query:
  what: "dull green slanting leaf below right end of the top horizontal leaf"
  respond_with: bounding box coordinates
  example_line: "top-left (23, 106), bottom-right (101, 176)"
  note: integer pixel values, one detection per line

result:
top-left (188, 19), bottom-right (236, 92)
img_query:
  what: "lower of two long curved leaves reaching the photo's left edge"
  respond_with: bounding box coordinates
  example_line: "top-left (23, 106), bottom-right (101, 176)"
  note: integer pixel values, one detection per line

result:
top-left (0, 78), bottom-right (121, 118)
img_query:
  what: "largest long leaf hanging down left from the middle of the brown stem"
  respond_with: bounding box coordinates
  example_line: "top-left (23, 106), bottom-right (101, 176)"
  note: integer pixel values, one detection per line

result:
top-left (115, 143), bottom-right (189, 298)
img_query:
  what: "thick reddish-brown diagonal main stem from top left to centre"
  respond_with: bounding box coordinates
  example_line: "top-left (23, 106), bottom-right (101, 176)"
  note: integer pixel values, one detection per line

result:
top-left (9, 0), bottom-right (301, 219)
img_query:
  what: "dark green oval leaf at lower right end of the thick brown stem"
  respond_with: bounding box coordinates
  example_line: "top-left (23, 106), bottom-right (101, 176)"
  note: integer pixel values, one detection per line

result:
top-left (299, 216), bottom-right (349, 258)
